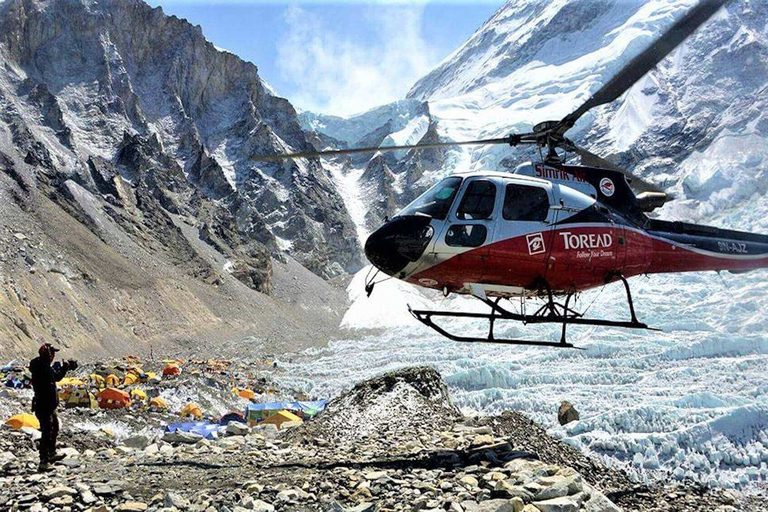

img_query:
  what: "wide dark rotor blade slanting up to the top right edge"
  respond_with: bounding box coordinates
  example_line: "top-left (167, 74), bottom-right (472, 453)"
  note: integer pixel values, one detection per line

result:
top-left (555, 0), bottom-right (730, 135)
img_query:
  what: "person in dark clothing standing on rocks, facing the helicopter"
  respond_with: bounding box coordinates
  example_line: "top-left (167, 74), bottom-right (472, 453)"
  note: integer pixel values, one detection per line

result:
top-left (29, 343), bottom-right (77, 471)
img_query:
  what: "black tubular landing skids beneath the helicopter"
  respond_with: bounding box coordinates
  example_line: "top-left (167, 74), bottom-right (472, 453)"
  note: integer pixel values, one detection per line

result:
top-left (408, 276), bottom-right (659, 350)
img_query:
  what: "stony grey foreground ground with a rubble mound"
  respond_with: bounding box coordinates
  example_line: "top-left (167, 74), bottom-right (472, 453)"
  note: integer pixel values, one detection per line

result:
top-left (0, 365), bottom-right (761, 512)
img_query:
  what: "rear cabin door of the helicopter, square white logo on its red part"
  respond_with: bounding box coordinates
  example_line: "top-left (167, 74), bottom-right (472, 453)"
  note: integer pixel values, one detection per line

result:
top-left (485, 181), bottom-right (555, 294)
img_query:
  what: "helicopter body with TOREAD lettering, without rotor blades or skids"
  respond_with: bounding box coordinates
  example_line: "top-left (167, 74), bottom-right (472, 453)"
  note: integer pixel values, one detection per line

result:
top-left (366, 165), bottom-right (768, 296)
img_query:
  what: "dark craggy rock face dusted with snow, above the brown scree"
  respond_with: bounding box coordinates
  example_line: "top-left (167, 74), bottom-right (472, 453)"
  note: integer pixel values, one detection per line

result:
top-left (0, 0), bottom-right (361, 291)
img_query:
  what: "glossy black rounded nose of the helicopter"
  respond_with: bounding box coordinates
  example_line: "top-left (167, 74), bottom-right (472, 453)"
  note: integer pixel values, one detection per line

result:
top-left (365, 215), bottom-right (434, 276)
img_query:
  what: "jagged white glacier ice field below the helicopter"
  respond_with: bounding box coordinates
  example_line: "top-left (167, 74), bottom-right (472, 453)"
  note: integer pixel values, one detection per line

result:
top-left (287, 270), bottom-right (768, 489)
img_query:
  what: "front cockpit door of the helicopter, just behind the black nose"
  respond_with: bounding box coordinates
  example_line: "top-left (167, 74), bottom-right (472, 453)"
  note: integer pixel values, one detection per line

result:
top-left (434, 178), bottom-right (498, 289)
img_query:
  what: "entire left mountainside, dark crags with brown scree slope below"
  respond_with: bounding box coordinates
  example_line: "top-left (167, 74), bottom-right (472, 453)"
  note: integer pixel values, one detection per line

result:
top-left (0, 0), bottom-right (361, 356)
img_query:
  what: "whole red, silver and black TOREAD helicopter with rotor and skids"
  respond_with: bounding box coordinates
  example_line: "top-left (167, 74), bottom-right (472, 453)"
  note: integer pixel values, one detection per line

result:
top-left (254, 0), bottom-right (768, 347)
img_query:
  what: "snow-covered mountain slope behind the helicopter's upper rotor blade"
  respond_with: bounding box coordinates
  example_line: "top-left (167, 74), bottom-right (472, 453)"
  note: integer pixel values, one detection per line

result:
top-left (408, 0), bottom-right (768, 228)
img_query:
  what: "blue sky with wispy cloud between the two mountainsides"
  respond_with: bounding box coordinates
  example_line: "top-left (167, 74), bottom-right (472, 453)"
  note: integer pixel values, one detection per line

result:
top-left (149, 0), bottom-right (503, 116)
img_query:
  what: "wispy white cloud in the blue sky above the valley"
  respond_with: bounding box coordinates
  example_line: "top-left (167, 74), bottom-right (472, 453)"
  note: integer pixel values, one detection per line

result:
top-left (277, 6), bottom-right (439, 116)
